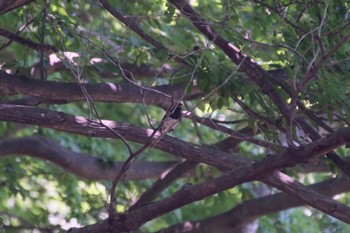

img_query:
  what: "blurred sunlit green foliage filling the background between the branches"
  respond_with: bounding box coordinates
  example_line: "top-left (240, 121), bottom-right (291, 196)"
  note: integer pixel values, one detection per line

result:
top-left (0, 0), bottom-right (350, 232)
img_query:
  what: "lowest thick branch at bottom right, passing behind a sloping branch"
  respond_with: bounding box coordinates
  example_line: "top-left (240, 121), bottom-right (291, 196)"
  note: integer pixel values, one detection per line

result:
top-left (159, 177), bottom-right (350, 233)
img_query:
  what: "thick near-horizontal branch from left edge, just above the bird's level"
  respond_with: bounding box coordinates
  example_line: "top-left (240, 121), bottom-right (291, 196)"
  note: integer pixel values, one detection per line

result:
top-left (0, 71), bottom-right (191, 108)
